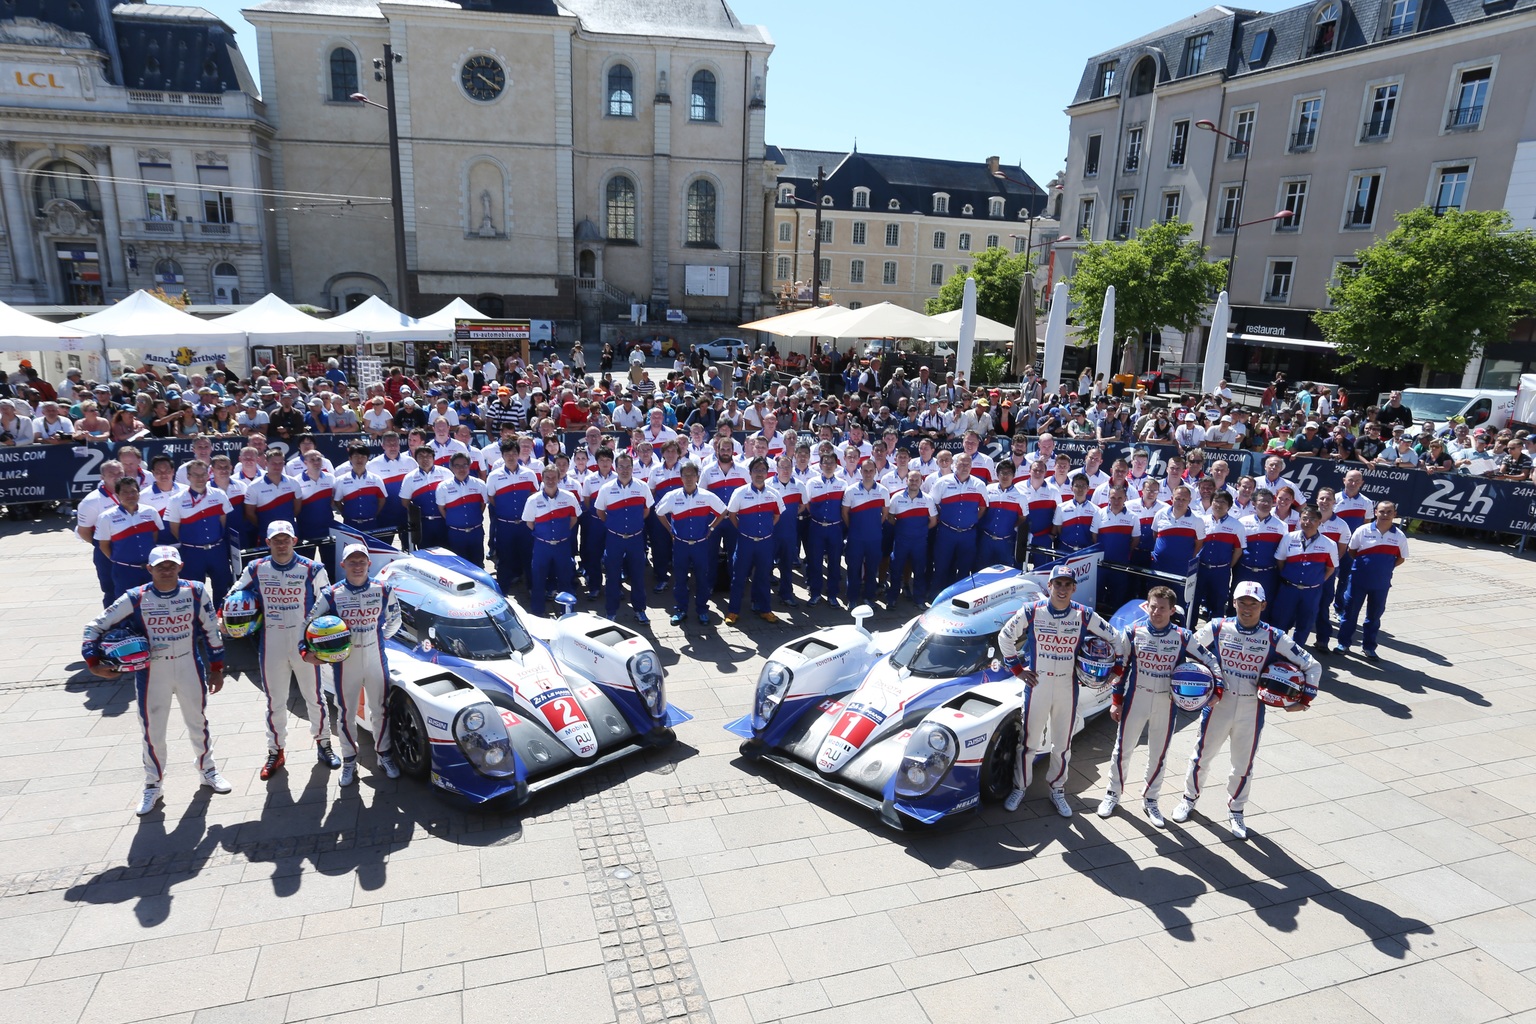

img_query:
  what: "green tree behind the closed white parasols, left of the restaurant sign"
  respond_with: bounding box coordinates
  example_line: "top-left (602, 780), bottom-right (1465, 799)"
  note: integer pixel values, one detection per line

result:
top-left (1069, 221), bottom-right (1227, 369)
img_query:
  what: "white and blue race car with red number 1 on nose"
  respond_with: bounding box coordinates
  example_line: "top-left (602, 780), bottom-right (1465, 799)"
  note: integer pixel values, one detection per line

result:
top-left (725, 553), bottom-right (1109, 827)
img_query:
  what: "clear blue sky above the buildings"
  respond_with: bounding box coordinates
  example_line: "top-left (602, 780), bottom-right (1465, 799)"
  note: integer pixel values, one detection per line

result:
top-left (201, 0), bottom-right (1207, 183)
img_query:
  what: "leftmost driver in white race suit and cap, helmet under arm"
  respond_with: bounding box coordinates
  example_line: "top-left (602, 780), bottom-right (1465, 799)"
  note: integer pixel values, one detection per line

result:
top-left (80, 543), bottom-right (230, 817)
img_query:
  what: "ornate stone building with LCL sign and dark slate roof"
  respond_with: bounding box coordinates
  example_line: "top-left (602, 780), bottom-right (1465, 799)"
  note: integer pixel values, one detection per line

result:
top-left (0, 0), bottom-right (275, 306)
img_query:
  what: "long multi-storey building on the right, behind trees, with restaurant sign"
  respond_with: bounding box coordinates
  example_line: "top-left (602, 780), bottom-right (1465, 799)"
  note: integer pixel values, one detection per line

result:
top-left (1063, 0), bottom-right (1536, 385)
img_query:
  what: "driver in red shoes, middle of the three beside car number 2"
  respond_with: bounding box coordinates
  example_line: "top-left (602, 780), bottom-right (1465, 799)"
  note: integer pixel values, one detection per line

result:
top-left (235, 520), bottom-right (341, 778)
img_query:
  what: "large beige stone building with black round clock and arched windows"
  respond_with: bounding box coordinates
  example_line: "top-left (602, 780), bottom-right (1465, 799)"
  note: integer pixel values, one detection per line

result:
top-left (246, 0), bottom-right (773, 322)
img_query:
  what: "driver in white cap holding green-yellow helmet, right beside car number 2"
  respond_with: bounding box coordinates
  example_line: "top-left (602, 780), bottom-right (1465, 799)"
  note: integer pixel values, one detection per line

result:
top-left (304, 542), bottom-right (401, 786)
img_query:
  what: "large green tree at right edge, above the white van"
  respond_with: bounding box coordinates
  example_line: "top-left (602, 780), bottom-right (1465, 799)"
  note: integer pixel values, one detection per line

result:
top-left (1313, 206), bottom-right (1536, 384)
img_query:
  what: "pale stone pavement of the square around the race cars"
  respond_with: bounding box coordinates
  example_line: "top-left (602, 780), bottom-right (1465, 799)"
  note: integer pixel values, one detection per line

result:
top-left (0, 520), bottom-right (1536, 1024)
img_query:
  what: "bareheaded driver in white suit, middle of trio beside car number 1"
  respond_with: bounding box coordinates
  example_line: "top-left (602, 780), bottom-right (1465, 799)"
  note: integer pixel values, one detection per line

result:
top-left (1098, 586), bottom-right (1226, 829)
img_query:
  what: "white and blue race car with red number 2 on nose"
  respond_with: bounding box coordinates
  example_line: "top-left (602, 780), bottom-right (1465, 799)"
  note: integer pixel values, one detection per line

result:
top-left (323, 527), bottom-right (693, 804)
